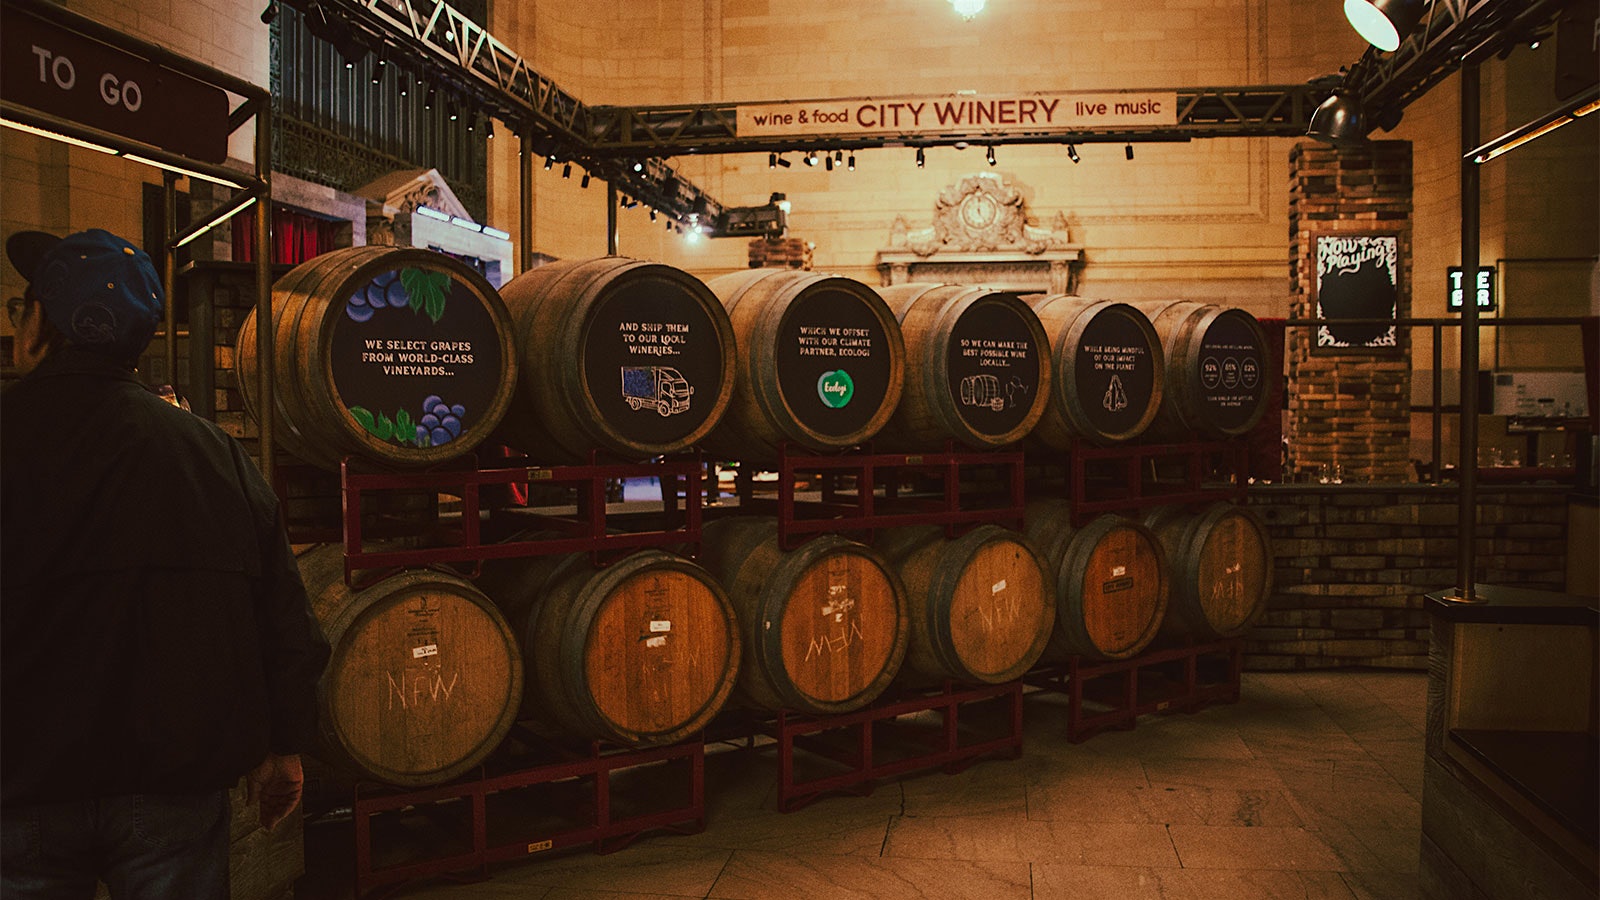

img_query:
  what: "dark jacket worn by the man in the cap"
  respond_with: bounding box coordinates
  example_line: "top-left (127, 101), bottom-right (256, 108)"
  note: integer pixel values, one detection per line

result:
top-left (0, 349), bottom-right (328, 806)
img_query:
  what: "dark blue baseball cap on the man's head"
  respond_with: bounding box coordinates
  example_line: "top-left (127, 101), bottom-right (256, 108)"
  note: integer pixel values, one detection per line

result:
top-left (5, 227), bottom-right (165, 362)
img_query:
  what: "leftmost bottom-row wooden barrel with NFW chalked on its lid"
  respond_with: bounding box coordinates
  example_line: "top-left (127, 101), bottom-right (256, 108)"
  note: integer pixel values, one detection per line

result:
top-left (299, 544), bottom-right (522, 786)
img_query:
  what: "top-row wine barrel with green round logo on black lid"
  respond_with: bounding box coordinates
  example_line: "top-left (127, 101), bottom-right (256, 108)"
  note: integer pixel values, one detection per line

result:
top-left (706, 269), bottom-right (906, 460)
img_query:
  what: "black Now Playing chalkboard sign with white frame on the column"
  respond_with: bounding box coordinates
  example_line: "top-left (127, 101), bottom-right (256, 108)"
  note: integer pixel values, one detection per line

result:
top-left (1314, 234), bottom-right (1400, 351)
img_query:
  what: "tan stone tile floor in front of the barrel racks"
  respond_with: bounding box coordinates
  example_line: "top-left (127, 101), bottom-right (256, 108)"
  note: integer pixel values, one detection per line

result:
top-left (301, 671), bottom-right (1427, 900)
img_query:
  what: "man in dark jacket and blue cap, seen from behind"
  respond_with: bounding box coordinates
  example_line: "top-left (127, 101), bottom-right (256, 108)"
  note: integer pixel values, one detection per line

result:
top-left (0, 229), bottom-right (328, 900)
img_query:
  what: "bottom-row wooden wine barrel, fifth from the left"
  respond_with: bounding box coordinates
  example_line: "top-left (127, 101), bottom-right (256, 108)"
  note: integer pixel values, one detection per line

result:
top-left (1024, 500), bottom-right (1170, 663)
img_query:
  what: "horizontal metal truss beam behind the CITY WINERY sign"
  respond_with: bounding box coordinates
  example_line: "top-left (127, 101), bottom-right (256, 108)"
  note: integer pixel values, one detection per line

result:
top-left (587, 83), bottom-right (1331, 157)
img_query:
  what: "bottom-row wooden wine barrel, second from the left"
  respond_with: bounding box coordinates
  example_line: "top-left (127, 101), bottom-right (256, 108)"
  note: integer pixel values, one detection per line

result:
top-left (478, 547), bottom-right (739, 746)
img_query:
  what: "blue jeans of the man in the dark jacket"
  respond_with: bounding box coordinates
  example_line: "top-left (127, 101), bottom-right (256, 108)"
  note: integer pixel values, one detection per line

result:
top-left (0, 791), bottom-right (232, 900)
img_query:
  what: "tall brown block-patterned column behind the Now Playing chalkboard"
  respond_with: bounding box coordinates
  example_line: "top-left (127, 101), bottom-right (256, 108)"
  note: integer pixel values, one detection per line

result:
top-left (1286, 141), bottom-right (1414, 482)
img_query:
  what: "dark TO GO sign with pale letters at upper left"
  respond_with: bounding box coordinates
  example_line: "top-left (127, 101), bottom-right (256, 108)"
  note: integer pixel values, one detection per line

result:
top-left (0, 6), bottom-right (229, 163)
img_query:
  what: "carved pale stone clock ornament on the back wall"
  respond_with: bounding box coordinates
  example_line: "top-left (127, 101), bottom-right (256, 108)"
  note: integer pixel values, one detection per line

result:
top-left (890, 171), bottom-right (1069, 256)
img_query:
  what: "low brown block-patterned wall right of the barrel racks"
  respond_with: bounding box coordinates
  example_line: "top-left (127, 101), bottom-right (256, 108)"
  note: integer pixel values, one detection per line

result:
top-left (1245, 485), bottom-right (1568, 671)
